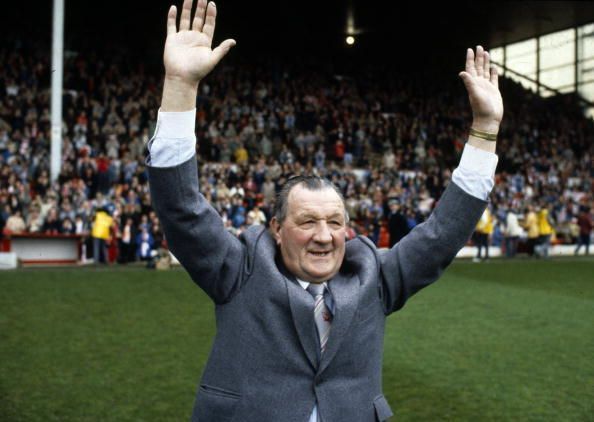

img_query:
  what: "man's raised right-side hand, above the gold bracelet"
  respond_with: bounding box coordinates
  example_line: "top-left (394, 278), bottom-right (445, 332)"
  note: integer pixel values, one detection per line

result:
top-left (459, 45), bottom-right (503, 134)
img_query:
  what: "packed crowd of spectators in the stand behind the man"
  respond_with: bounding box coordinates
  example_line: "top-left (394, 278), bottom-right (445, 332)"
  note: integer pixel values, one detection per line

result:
top-left (0, 41), bottom-right (594, 263)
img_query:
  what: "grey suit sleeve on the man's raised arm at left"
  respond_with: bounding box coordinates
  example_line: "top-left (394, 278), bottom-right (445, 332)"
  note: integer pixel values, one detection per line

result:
top-left (148, 156), bottom-right (245, 304)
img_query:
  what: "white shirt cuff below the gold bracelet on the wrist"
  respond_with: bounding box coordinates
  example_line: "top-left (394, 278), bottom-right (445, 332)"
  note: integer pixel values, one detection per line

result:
top-left (452, 144), bottom-right (499, 201)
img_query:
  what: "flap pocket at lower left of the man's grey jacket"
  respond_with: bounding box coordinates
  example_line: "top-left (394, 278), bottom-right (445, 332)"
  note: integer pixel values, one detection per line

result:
top-left (192, 384), bottom-right (241, 422)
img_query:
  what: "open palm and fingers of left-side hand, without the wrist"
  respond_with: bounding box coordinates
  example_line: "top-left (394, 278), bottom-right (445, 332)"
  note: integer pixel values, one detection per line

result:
top-left (163, 0), bottom-right (235, 83)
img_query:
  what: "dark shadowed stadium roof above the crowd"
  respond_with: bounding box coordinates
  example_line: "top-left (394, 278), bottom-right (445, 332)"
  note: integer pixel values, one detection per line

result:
top-left (0, 0), bottom-right (594, 65)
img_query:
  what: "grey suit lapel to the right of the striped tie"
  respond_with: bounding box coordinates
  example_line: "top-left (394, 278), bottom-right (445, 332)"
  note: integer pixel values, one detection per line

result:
top-left (316, 273), bottom-right (359, 373)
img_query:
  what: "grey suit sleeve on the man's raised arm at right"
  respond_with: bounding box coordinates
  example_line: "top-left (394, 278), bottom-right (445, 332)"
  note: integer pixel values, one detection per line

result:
top-left (379, 182), bottom-right (487, 314)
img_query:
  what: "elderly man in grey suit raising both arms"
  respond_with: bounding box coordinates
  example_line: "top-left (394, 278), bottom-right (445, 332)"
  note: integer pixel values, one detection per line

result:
top-left (148, 0), bottom-right (503, 422)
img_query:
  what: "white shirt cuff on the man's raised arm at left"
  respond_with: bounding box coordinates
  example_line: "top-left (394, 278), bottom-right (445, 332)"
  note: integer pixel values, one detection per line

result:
top-left (147, 109), bottom-right (196, 167)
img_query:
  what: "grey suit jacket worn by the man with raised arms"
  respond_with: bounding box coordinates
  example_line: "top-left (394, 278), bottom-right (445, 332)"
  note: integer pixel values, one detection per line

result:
top-left (149, 158), bottom-right (486, 422)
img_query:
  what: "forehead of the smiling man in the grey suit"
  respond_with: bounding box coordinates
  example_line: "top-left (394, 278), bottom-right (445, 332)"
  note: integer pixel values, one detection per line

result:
top-left (287, 185), bottom-right (344, 216)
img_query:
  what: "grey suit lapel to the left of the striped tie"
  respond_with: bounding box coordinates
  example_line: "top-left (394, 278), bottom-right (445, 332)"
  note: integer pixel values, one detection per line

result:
top-left (284, 276), bottom-right (320, 368)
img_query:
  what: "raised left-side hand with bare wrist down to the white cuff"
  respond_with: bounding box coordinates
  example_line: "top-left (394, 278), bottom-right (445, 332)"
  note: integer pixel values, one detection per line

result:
top-left (161, 0), bottom-right (235, 111)
